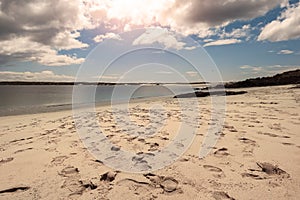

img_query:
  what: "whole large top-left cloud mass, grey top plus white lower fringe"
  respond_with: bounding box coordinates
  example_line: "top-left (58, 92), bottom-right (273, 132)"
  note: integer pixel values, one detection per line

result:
top-left (0, 0), bottom-right (92, 65)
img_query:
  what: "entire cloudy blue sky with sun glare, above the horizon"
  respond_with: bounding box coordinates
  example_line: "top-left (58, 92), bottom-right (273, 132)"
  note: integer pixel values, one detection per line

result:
top-left (0, 0), bottom-right (300, 82)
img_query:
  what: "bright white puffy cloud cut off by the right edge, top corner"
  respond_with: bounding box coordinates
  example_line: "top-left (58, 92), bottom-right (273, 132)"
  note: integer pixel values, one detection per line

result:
top-left (258, 2), bottom-right (300, 42)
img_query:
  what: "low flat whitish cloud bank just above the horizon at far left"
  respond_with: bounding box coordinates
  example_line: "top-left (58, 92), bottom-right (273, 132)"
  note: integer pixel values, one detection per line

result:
top-left (0, 71), bottom-right (75, 82)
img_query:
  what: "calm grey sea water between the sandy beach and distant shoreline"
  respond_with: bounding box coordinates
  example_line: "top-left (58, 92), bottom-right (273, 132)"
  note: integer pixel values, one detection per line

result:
top-left (0, 85), bottom-right (202, 116)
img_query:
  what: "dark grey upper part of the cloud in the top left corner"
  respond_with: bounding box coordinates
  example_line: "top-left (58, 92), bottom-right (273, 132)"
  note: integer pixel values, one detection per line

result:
top-left (0, 0), bottom-right (87, 45)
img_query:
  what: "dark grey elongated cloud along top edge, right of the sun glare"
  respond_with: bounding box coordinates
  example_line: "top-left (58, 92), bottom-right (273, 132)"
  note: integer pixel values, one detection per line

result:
top-left (173, 0), bottom-right (282, 26)
